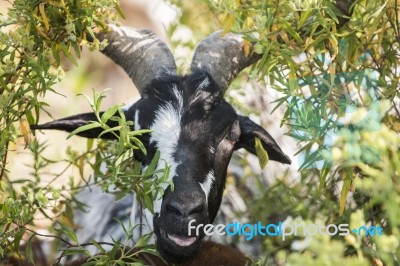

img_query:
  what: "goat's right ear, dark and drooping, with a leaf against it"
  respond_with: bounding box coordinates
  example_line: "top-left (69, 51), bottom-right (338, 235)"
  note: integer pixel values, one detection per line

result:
top-left (235, 115), bottom-right (292, 164)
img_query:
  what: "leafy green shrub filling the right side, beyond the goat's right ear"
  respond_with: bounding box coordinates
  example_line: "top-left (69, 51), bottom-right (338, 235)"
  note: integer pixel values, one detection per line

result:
top-left (208, 1), bottom-right (400, 265)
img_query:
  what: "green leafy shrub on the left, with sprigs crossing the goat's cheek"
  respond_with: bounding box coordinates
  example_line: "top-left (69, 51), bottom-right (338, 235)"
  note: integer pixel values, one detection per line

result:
top-left (0, 0), bottom-right (162, 264)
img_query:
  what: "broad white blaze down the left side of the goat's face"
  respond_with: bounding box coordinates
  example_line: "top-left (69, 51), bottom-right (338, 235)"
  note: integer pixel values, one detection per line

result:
top-left (150, 86), bottom-right (183, 213)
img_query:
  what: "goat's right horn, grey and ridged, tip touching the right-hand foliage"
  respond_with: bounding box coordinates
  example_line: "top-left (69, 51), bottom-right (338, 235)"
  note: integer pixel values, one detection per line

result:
top-left (190, 31), bottom-right (261, 93)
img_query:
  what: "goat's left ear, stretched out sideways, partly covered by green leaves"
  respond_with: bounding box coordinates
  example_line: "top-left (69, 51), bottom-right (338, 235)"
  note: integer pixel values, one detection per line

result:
top-left (30, 112), bottom-right (124, 139)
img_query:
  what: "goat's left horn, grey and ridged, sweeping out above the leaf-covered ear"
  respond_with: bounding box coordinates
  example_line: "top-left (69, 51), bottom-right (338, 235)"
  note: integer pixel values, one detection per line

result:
top-left (96, 25), bottom-right (176, 95)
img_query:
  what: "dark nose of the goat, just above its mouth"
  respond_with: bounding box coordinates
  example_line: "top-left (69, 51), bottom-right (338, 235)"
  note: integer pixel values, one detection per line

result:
top-left (165, 199), bottom-right (204, 218)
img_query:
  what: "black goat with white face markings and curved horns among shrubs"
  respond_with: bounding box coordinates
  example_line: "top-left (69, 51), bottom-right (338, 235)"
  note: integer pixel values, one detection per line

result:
top-left (32, 25), bottom-right (291, 262)
